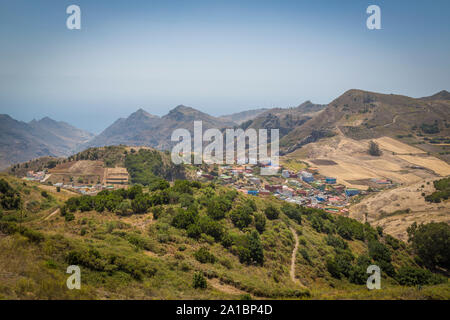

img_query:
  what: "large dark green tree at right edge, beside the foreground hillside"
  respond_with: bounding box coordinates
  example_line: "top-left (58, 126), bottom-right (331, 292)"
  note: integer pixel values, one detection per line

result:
top-left (407, 222), bottom-right (450, 270)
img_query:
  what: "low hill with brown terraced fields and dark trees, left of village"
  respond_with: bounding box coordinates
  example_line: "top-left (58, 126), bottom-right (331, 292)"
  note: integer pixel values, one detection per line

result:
top-left (6, 145), bottom-right (187, 185)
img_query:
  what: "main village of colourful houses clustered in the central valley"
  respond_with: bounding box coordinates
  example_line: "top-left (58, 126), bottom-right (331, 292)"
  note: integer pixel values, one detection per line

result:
top-left (197, 163), bottom-right (393, 214)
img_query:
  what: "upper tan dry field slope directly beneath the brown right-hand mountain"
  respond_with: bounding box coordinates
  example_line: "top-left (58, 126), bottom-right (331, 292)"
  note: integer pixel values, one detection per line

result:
top-left (283, 135), bottom-right (450, 189)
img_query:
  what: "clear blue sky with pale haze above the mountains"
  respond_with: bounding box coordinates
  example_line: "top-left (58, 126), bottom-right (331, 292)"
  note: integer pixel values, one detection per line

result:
top-left (0, 0), bottom-right (450, 133)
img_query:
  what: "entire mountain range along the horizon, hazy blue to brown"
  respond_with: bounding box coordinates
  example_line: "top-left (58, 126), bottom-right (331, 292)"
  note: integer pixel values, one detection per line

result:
top-left (0, 90), bottom-right (450, 169)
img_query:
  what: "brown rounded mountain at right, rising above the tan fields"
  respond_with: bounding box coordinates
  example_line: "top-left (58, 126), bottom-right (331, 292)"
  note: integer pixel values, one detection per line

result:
top-left (280, 90), bottom-right (450, 151)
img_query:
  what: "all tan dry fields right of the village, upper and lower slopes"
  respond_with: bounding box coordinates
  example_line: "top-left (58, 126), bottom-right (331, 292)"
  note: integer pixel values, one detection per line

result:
top-left (283, 135), bottom-right (450, 240)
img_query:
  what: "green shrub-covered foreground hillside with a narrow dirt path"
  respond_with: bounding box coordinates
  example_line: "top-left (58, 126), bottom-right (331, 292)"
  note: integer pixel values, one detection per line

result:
top-left (0, 175), bottom-right (450, 299)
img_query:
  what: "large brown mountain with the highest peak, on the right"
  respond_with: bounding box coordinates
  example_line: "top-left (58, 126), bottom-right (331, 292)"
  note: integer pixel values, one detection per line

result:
top-left (280, 90), bottom-right (450, 160)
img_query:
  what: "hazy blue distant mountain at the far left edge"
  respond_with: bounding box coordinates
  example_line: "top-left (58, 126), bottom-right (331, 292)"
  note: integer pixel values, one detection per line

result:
top-left (0, 115), bottom-right (93, 170)
